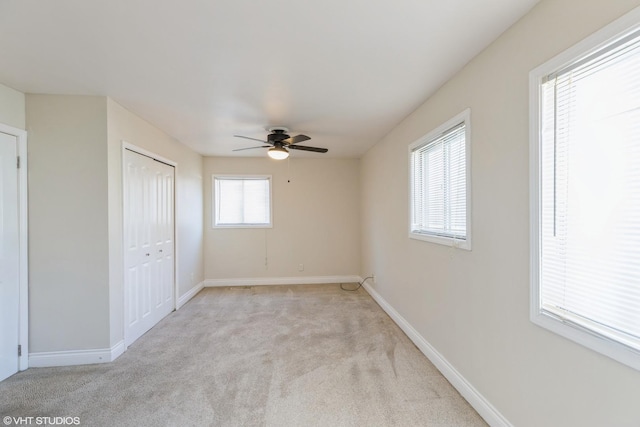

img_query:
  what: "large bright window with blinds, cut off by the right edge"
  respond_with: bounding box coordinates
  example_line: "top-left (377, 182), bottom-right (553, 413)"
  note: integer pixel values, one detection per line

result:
top-left (530, 13), bottom-right (640, 369)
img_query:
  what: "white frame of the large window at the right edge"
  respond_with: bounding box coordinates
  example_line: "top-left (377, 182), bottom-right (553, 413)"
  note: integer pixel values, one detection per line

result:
top-left (529, 8), bottom-right (640, 370)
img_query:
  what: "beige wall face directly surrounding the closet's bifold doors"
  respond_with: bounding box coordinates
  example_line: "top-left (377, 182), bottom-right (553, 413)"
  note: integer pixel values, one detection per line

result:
top-left (107, 99), bottom-right (204, 345)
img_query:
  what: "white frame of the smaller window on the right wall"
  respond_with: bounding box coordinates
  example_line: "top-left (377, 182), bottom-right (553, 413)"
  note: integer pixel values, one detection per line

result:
top-left (408, 108), bottom-right (471, 251)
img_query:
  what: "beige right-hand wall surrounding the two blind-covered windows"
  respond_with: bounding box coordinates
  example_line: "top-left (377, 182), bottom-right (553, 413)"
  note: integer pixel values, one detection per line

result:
top-left (361, 0), bottom-right (640, 427)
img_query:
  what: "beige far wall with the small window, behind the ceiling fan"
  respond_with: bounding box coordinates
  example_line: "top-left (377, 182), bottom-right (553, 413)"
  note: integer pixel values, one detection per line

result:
top-left (204, 153), bottom-right (360, 279)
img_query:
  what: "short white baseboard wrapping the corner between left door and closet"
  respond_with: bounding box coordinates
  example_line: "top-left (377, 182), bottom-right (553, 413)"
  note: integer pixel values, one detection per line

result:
top-left (29, 341), bottom-right (125, 368)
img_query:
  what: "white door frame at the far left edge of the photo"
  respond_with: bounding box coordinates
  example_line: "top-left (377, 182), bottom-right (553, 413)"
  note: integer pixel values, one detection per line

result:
top-left (0, 123), bottom-right (29, 371)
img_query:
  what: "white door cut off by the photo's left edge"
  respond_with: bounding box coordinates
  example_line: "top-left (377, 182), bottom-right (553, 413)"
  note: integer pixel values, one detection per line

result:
top-left (0, 132), bottom-right (20, 381)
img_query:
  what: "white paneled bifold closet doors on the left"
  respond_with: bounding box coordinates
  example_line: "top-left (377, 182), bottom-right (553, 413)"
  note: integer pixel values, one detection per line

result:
top-left (124, 150), bottom-right (175, 346)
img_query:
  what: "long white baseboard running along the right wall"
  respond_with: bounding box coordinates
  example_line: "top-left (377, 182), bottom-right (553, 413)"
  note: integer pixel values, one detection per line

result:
top-left (363, 282), bottom-right (512, 427)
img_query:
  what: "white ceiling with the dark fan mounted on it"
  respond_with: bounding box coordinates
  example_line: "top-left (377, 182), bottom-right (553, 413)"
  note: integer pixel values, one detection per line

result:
top-left (0, 0), bottom-right (538, 157)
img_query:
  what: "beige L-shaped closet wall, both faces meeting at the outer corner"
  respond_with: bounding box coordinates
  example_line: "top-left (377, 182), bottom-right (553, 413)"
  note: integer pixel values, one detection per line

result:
top-left (26, 95), bottom-right (204, 353)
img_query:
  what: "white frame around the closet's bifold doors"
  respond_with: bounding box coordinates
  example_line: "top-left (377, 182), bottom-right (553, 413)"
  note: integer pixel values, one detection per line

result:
top-left (120, 140), bottom-right (178, 351)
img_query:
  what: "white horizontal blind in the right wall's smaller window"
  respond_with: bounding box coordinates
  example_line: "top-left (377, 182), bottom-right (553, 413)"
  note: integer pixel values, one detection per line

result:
top-left (411, 122), bottom-right (467, 240)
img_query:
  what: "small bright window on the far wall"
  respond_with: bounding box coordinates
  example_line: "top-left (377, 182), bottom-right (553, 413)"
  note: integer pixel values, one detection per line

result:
top-left (213, 175), bottom-right (271, 228)
